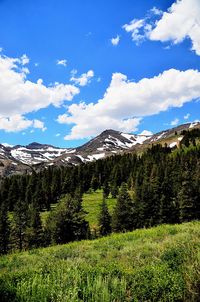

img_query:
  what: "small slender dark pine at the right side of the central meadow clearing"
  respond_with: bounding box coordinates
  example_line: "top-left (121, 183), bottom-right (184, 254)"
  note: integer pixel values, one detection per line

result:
top-left (98, 199), bottom-right (111, 236)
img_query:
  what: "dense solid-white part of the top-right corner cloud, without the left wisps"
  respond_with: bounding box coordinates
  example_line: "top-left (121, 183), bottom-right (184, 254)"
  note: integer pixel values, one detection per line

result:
top-left (149, 0), bottom-right (200, 55)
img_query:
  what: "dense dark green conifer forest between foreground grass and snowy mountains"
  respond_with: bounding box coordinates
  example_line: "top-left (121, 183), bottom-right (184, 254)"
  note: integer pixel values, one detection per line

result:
top-left (0, 129), bottom-right (200, 254)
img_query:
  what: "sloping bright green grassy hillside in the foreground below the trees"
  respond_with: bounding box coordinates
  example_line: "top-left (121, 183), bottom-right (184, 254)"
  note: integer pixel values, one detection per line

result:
top-left (0, 222), bottom-right (200, 302)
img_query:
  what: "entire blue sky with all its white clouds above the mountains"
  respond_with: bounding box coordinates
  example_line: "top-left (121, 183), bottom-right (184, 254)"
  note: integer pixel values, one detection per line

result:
top-left (0, 0), bottom-right (200, 147)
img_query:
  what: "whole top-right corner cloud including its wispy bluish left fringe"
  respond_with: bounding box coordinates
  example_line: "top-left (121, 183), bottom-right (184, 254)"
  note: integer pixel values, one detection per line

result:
top-left (123, 0), bottom-right (200, 55)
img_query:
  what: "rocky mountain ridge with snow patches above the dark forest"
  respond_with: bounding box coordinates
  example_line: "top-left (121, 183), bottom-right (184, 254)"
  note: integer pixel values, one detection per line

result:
top-left (0, 122), bottom-right (200, 176)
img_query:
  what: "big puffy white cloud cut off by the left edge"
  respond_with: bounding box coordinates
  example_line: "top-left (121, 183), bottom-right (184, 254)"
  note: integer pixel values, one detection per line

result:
top-left (0, 55), bottom-right (79, 131)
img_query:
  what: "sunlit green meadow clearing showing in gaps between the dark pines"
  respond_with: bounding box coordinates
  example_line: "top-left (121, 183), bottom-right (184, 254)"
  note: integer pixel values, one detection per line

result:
top-left (41, 190), bottom-right (116, 230)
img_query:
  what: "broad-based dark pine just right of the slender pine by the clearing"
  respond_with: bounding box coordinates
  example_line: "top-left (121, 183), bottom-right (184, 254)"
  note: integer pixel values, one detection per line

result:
top-left (112, 183), bottom-right (134, 232)
